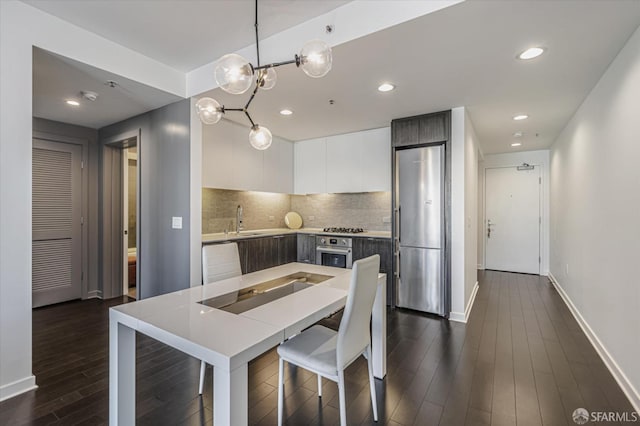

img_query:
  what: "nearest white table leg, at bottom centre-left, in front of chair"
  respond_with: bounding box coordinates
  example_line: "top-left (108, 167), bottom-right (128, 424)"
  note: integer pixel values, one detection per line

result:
top-left (213, 364), bottom-right (249, 426)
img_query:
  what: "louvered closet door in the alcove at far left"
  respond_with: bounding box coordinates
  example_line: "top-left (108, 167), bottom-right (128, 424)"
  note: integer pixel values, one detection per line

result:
top-left (31, 139), bottom-right (82, 308)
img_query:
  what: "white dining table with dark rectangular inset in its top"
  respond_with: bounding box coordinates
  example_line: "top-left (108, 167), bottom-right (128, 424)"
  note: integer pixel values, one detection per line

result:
top-left (109, 263), bottom-right (387, 426)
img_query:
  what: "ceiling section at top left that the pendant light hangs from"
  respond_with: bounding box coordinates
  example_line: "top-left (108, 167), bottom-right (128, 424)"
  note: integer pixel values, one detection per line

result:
top-left (23, 0), bottom-right (348, 72)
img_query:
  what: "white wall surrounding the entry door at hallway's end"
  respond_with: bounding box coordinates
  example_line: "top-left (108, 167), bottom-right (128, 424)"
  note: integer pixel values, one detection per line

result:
top-left (478, 150), bottom-right (549, 275)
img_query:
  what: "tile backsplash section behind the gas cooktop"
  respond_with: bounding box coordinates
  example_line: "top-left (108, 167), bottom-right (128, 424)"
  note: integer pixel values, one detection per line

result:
top-left (291, 192), bottom-right (391, 231)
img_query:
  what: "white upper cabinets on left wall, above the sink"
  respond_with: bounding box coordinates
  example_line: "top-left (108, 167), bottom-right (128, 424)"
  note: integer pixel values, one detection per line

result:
top-left (202, 122), bottom-right (293, 194)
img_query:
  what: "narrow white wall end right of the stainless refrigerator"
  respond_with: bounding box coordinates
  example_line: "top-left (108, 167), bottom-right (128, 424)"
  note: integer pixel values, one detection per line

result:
top-left (450, 107), bottom-right (478, 322)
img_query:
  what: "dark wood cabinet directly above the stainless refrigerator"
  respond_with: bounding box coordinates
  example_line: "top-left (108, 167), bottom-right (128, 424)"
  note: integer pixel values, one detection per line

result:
top-left (391, 111), bottom-right (451, 147)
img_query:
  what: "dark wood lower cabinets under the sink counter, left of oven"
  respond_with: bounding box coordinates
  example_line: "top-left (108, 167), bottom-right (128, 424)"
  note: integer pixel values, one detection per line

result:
top-left (235, 234), bottom-right (297, 274)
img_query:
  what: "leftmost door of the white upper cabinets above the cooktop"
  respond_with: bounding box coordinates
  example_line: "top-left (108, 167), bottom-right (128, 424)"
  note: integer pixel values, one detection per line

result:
top-left (293, 138), bottom-right (327, 194)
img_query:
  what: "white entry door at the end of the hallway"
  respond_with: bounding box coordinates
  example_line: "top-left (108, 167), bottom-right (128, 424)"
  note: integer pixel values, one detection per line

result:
top-left (484, 166), bottom-right (540, 274)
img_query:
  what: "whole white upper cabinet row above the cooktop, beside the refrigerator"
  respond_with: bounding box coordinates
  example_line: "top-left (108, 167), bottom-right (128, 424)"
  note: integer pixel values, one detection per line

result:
top-left (294, 127), bottom-right (391, 194)
